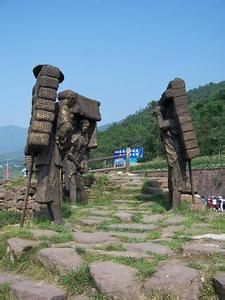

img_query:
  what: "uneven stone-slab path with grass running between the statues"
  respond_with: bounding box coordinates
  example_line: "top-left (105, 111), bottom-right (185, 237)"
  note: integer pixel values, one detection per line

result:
top-left (0, 175), bottom-right (225, 300)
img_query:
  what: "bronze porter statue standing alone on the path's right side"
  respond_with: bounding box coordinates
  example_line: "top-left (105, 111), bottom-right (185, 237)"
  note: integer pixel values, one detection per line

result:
top-left (154, 78), bottom-right (199, 209)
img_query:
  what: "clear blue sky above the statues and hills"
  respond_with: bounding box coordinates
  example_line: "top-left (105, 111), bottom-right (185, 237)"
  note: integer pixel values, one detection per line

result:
top-left (0, 0), bottom-right (225, 127)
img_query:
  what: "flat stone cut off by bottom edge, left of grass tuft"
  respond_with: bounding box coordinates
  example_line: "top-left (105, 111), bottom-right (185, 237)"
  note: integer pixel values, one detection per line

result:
top-left (11, 280), bottom-right (67, 300)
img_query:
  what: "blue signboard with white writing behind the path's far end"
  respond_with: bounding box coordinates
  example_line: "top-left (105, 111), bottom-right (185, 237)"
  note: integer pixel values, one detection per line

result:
top-left (113, 147), bottom-right (143, 167)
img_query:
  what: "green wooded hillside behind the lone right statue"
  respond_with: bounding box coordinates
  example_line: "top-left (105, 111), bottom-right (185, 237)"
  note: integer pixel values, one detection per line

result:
top-left (92, 81), bottom-right (225, 161)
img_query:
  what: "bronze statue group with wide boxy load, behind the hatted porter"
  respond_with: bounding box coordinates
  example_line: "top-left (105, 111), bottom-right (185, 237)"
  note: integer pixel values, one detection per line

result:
top-left (57, 90), bottom-right (101, 205)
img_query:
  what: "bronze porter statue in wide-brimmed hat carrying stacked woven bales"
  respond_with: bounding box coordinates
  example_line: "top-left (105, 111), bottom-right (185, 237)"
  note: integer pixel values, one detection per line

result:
top-left (25, 65), bottom-right (64, 224)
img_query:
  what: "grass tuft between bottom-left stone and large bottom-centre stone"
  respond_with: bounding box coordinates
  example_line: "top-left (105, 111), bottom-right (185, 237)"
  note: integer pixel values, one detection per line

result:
top-left (59, 265), bottom-right (93, 295)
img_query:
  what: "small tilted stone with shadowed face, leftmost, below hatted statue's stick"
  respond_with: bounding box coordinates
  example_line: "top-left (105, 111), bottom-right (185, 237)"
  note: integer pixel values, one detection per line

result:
top-left (7, 238), bottom-right (41, 259)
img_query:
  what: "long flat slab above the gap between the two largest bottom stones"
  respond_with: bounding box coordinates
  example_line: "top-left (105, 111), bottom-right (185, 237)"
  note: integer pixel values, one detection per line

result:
top-left (124, 242), bottom-right (175, 256)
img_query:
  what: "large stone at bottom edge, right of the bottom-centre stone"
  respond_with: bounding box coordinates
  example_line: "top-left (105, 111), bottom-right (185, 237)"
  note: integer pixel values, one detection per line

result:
top-left (144, 263), bottom-right (202, 300)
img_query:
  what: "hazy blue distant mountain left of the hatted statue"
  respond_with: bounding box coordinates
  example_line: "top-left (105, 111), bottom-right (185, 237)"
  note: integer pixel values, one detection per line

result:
top-left (0, 125), bottom-right (27, 155)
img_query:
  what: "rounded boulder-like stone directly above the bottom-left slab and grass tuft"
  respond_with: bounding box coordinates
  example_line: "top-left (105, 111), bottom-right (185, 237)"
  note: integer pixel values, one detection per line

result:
top-left (34, 248), bottom-right (83, 274)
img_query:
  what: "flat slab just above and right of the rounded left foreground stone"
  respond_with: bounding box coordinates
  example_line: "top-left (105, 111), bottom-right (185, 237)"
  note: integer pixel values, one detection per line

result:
top-left (73, 231), bottom-right (118, 244)
